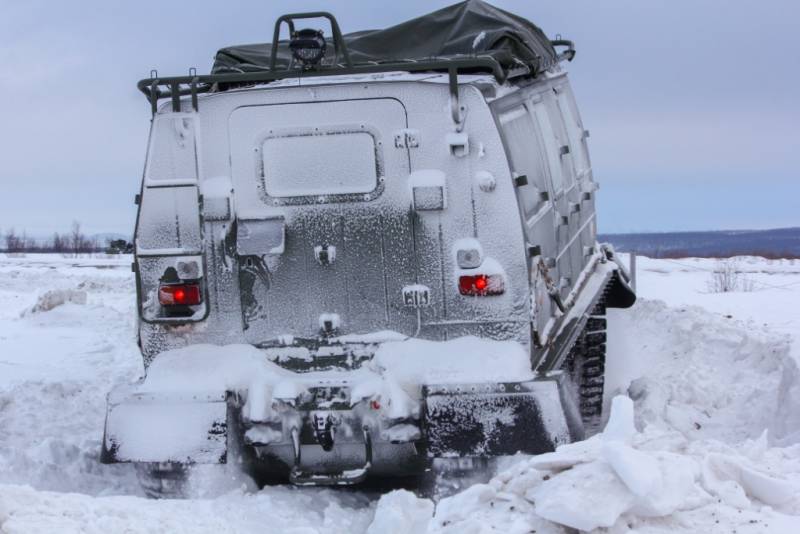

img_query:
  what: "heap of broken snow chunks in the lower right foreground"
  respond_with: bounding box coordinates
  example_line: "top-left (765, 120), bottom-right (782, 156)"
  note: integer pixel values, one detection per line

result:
top-left (432, 396), bottom-right (800, 532)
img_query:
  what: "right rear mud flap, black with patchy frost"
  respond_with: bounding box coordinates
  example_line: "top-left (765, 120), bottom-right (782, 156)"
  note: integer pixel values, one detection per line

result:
top-left (423, 377), bottom-right (582, 458)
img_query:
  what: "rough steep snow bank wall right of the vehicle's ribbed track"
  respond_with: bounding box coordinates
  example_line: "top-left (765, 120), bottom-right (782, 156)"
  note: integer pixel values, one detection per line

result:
top-left (606, 300), bottom-right (800, 445)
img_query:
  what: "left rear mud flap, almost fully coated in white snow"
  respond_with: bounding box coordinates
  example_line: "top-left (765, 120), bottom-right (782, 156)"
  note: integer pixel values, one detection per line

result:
top-left (100, 392), bottom-right (228, 463)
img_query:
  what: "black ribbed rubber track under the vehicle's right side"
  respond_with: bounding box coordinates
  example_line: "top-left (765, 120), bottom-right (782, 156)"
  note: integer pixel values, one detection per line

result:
top-left (564, 303), bottom-right (606, 437)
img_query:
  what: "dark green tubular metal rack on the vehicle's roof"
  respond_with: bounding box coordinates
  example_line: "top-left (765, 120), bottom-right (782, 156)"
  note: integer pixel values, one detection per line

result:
top-left (137, 11), bottom-right (575, 124)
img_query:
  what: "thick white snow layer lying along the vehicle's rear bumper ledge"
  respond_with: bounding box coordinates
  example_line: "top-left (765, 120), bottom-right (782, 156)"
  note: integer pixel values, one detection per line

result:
top-left (136, 333), bottom-right (533, 396)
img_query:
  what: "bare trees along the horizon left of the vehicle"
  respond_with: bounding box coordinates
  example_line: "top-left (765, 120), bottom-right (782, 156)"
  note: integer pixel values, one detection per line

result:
top-left (0, 221), bottom-right (132, 254)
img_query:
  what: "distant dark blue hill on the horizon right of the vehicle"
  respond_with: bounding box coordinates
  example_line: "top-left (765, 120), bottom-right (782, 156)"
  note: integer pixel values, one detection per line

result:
top-left (598, 228), bottom-right (800, 258)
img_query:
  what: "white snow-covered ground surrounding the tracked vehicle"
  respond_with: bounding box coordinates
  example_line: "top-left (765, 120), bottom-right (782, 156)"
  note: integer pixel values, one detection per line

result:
top-left (0, 256), bottom-right (800, 534)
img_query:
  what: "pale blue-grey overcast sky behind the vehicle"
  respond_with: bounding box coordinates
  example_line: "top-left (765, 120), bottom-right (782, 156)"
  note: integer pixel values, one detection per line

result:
top-left (0, 0), bottom-right (800, 234)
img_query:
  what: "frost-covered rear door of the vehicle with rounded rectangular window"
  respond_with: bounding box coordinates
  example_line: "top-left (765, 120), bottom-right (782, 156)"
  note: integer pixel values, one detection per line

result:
top-left (230, 98), bottom-right (416, 343)
